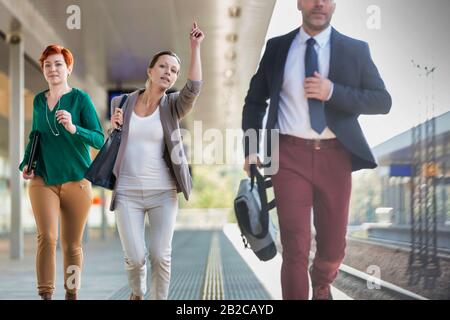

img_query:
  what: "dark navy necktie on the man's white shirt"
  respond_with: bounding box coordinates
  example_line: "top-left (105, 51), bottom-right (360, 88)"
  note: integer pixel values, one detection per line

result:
top-left (305, 38), bottom-right (327, 134)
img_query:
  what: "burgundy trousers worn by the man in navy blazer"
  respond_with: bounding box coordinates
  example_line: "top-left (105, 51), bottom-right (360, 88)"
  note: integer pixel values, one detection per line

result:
top-left (272, 135), bottom-right (352, 300)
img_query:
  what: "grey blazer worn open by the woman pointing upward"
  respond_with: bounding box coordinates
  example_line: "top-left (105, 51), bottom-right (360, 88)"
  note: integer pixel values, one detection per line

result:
top-left (110, 79), bottom-right (202, 211)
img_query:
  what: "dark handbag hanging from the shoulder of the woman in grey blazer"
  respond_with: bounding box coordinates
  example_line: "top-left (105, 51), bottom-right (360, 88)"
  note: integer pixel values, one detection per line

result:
top-left (84, 95), bottom-right (128, 190)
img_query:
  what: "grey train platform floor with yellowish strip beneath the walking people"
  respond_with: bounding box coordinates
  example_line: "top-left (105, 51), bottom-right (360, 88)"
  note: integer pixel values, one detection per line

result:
top-left (0, 224), bottom-right (351, 300)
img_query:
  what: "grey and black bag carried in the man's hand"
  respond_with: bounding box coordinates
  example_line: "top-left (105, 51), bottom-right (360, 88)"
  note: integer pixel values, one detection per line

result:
top-left (234, 165), bottom-right (277, 261)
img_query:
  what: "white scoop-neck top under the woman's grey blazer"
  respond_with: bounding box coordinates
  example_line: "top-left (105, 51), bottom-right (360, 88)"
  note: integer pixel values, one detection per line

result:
top-left (117, 106), bottom-right (176, 191)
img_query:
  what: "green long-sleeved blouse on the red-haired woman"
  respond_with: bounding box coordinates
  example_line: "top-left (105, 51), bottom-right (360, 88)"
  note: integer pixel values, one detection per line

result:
top-left (19, 88), bottom-right (104, 185)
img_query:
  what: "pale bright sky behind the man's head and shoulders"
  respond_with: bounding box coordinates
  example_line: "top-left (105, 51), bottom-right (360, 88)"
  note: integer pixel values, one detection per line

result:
top-left (266, 0), bottom-right (450, 147)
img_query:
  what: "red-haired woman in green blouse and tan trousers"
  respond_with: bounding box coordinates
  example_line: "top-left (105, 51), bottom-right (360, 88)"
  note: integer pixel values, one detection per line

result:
top-left (19, 45), bottom-right (104, 300)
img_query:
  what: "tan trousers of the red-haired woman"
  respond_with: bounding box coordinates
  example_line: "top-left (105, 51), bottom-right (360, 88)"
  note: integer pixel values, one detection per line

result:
top-left (28, 177), bottom-right (93, 295)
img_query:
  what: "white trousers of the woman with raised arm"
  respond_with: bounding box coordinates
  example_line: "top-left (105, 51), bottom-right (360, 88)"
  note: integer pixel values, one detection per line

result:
top-left (115, 190), bottom-right (178, 300)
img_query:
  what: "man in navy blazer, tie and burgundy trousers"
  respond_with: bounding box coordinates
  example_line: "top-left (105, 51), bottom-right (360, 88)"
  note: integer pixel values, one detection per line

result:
top-left (242, 0), bottom-right (392, 299)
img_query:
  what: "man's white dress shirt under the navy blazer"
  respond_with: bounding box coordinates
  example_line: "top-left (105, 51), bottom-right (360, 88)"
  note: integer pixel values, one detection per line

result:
top-left (277, 26), bottom-right (336, 139)
